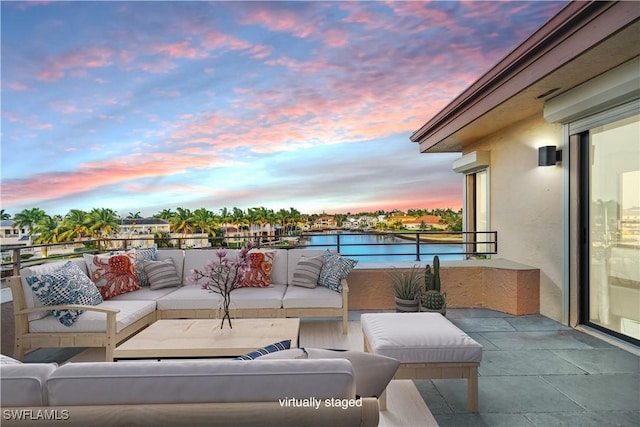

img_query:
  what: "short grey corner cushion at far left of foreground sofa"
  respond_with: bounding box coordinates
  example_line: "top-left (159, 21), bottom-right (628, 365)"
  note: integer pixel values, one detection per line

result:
top-left (0, 363), bottom-right (58, 408)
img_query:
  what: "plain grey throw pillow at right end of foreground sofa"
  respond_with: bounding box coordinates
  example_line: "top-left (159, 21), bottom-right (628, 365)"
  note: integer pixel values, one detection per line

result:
top-left (305, 348), bottom-right (400, 397)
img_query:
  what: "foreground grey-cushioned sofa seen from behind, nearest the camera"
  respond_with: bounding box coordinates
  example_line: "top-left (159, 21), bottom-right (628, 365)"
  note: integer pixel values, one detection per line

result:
top-left (0, 359), bottom-right (379, 427)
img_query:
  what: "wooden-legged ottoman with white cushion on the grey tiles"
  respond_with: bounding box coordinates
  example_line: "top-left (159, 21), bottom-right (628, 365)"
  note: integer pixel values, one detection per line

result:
top-left (360, 313), bottom-right (482, 412)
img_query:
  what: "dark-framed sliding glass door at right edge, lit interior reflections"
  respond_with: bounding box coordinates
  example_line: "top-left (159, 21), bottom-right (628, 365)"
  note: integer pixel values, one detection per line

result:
top-left (577, 115), bottom-right (640, 344)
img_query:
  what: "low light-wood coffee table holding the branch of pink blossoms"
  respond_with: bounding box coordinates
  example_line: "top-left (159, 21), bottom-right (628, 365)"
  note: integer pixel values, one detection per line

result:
top-left (113, 318), bottom-right (300, 360)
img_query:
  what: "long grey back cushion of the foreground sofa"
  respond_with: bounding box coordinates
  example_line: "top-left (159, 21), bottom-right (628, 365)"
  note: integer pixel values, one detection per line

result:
top-left (45, 359), bottom-right (355, 406)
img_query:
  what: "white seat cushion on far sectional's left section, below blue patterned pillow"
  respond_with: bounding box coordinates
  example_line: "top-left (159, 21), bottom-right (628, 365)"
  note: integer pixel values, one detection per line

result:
top-left (29, 300), bottom-right (156, 333)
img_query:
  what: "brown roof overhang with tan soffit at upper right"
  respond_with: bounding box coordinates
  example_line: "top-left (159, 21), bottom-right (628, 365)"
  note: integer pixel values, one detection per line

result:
top-left (411, 2), bottom-right (640, 153)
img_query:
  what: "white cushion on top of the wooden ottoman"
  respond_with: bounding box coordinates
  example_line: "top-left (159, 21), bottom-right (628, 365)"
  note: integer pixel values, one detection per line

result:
top-left (360, 313), bottom-right (482, 363)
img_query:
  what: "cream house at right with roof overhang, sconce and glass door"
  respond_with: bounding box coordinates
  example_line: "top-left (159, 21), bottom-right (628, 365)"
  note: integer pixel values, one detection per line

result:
top-left (411, 1), bottom-right (640, 345)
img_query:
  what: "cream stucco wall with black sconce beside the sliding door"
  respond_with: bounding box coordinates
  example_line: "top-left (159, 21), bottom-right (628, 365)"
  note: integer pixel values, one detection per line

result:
top-left (464, 114), bottom-right (563, 321)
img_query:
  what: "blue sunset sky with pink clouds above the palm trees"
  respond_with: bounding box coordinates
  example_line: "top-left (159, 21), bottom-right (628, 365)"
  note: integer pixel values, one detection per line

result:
top-left (0, 1), bottom-right (566, 216)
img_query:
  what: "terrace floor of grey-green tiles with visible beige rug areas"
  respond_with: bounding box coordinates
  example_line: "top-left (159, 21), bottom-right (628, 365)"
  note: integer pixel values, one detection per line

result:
top-left (1, 304), bottom-right (640, 427)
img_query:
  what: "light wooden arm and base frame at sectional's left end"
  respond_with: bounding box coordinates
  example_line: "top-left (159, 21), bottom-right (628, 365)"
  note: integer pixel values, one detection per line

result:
top-left (7, 276), bottom-right (157, 362)
